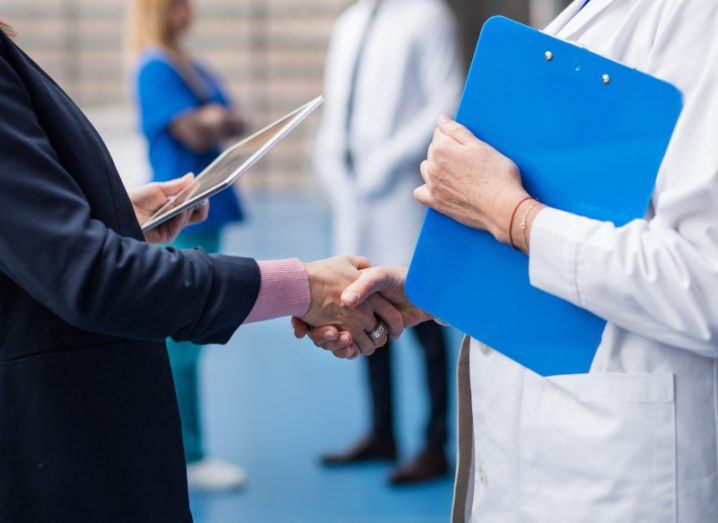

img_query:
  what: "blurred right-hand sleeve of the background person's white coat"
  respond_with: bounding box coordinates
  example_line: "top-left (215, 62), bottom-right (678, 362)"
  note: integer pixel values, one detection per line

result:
top-left (357, 6), bottom-right (465, 197)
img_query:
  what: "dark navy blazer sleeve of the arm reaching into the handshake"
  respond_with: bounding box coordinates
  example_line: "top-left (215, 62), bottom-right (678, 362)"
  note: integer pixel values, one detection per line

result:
top-left (0, 53), bottom-right (260, 343)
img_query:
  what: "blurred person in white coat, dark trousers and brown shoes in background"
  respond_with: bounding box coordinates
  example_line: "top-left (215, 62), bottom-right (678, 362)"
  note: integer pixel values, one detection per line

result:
top-left (316, 0), bottom-right (464, 484)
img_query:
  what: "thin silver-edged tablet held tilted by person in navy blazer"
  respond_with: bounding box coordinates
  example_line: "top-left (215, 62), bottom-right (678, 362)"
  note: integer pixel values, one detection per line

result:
top-left (142, 96), bottom-right (324, 232)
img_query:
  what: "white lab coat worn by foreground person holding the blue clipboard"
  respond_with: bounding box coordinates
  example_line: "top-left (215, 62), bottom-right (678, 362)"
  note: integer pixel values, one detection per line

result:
top-left (454, 0), bottom-right (718, 523)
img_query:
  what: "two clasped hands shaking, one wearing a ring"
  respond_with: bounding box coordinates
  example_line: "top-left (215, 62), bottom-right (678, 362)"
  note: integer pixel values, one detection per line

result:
top-left (292, 256), bottom-right (432, 359)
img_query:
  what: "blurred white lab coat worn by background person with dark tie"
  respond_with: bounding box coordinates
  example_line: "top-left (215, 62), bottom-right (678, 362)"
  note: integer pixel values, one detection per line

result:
top-left (315, 0), bottom-right (464, 265)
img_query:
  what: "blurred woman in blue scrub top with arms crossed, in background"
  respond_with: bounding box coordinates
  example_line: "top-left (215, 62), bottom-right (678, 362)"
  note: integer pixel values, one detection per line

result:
top-left (127, 0), bottom-right (252, 490)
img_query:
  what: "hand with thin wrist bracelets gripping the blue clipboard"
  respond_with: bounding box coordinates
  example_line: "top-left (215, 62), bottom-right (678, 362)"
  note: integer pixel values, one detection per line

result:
top-left (414, 116), bottom-right (541, 250)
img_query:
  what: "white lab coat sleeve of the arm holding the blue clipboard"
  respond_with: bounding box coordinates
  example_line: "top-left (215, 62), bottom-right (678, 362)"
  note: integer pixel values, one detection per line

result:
top-left (529, 3), bottom-right (718, 357)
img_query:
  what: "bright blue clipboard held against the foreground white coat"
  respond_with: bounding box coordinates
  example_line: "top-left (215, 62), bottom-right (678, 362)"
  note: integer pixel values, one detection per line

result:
top-left (407, 17), bottom-right (682, 376)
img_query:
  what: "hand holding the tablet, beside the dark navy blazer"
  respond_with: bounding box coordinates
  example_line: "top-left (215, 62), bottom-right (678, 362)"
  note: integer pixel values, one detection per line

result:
top-left (129, 173), bottom-right (209, 243)
